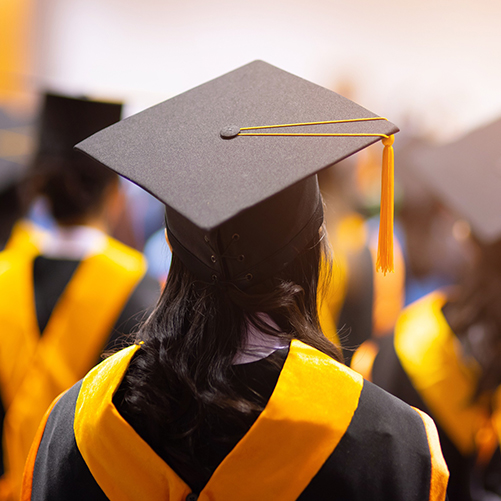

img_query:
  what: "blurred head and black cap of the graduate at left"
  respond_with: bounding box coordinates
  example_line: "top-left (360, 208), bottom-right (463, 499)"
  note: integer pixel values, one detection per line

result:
top-left (29, 94), bottom-right (121, 225)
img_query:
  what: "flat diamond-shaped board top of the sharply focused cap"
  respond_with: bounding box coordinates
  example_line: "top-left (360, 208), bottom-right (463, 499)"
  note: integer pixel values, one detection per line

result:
top-left (77, 61), bottom-right (398, 229)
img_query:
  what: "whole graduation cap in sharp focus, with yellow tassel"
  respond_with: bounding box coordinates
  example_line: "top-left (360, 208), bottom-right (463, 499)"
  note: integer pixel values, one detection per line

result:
top-left (77, 61), bottom-right (398, 289)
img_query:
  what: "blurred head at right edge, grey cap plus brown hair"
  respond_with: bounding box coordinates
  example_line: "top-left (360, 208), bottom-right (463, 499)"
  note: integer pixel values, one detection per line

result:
top-left (402, 120), bottom-right (501, 394)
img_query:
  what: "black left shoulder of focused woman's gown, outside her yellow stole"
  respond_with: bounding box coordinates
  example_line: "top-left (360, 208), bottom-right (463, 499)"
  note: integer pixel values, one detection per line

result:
top-left (31, 382), bottom-right (108, 501)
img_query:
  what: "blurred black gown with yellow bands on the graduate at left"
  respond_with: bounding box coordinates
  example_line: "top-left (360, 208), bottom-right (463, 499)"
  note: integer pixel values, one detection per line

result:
top-left (0, 237), bottom-right (159, 498)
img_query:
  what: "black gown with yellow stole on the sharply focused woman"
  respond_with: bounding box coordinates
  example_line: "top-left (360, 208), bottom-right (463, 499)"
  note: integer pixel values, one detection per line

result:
top-left (24, 341), bottom-right (448, 501)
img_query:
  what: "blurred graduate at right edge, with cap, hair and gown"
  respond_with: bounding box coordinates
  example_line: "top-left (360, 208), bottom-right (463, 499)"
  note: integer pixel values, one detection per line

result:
top-left (354, 120), bottom-right (501, 501)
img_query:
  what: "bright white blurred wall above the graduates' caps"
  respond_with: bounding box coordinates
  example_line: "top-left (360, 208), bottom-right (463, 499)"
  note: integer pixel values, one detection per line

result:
top-left (35, 0), bottom-right (501, 138)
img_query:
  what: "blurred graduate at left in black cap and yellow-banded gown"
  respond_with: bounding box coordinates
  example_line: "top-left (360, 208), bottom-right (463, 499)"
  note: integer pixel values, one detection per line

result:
top-left (0, 94), bottom-right (159, 499)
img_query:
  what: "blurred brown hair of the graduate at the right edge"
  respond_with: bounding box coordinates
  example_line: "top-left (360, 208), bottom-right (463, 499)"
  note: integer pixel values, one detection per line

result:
top-left (444, 236), bottom-right (501, 398)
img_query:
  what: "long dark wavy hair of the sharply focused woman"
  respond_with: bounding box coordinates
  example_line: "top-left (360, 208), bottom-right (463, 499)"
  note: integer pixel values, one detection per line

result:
top-left (120, 225), bottom-right (342, 462)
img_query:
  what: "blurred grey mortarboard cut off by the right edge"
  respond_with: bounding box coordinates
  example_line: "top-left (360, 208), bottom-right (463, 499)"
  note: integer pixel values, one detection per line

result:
top-left (412, 119), bottom-right (501, 244)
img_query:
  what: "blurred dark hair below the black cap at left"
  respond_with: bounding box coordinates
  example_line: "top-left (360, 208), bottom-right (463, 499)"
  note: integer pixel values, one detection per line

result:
top-left (29, 152), bottom-right (118, 224)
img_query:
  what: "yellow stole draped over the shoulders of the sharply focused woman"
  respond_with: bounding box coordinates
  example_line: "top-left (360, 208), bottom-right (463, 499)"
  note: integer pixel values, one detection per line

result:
top-left (74, 340), bottom-right (363, 501)
